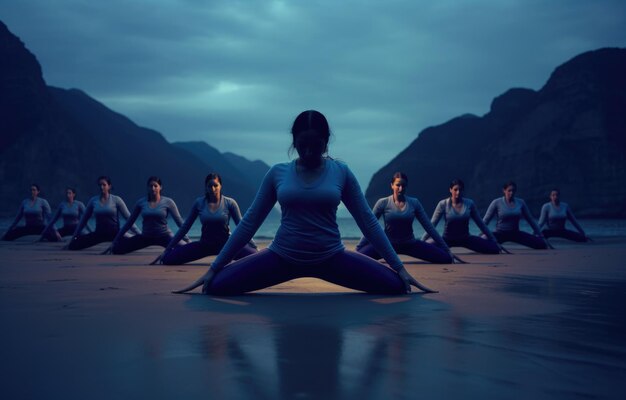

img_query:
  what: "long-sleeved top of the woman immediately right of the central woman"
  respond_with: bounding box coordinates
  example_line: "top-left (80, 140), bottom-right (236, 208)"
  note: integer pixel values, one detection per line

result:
top-left (357, 195), bottom-right (450, 251)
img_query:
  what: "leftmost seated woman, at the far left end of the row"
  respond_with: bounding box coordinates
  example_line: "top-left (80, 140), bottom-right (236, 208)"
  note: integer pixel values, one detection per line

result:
top-left (2, 183), bottom-right (50, 240)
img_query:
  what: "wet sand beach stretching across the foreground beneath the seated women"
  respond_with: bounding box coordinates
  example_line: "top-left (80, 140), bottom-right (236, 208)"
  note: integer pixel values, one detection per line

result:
top-left (0, 238), bottom-right (626, 399)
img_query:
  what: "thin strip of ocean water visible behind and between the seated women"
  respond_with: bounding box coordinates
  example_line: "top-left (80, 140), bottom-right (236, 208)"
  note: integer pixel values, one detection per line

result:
top-left (0, 216), bottom-right (626, 240)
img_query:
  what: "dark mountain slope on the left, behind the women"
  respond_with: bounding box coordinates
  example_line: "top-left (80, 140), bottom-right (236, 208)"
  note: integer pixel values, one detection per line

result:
top-left (0, 22), bottom-right (260, 214)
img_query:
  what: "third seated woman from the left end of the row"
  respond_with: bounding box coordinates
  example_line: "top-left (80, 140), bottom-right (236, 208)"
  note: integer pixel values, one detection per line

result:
top-left (66, 176), bottom-right (139, 250)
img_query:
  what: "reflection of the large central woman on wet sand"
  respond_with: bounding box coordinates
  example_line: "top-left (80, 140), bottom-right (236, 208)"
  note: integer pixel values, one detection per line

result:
top-left (185, 294), bottom-right (423, 399)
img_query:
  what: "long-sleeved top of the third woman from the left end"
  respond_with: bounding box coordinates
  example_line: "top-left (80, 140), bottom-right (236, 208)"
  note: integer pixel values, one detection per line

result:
top-left (74, 194), bottom-right (139, 236)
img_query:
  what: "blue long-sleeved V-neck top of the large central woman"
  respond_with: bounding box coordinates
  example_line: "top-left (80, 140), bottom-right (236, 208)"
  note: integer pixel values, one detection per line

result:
top-left (211, 159), bottom-right (402, 270)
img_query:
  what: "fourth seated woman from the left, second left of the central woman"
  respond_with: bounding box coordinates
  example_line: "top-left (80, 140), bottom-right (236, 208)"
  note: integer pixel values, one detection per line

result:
top-left (105, 176), bottom-right (189, 254)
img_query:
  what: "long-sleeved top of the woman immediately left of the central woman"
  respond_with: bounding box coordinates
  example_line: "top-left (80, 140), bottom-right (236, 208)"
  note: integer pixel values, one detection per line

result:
top-left (167, 195), bottom-right (256, 249)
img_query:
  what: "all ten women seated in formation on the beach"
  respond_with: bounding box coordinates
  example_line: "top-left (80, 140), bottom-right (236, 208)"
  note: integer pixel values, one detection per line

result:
top-left (3, 110), bottom-right (586, 295)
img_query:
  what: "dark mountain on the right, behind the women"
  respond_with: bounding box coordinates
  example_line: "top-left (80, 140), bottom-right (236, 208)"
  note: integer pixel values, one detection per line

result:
top-left (366, 48), bottom-right (626, 217)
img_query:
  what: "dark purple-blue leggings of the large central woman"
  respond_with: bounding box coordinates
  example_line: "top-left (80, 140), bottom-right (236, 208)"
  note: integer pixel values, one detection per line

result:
top-left (207, 249), bottom-right (405, 296)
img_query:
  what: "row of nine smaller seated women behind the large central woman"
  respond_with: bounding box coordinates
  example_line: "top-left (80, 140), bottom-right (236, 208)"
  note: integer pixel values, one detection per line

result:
top-left (3, 172), bottom-right (588, 264)
